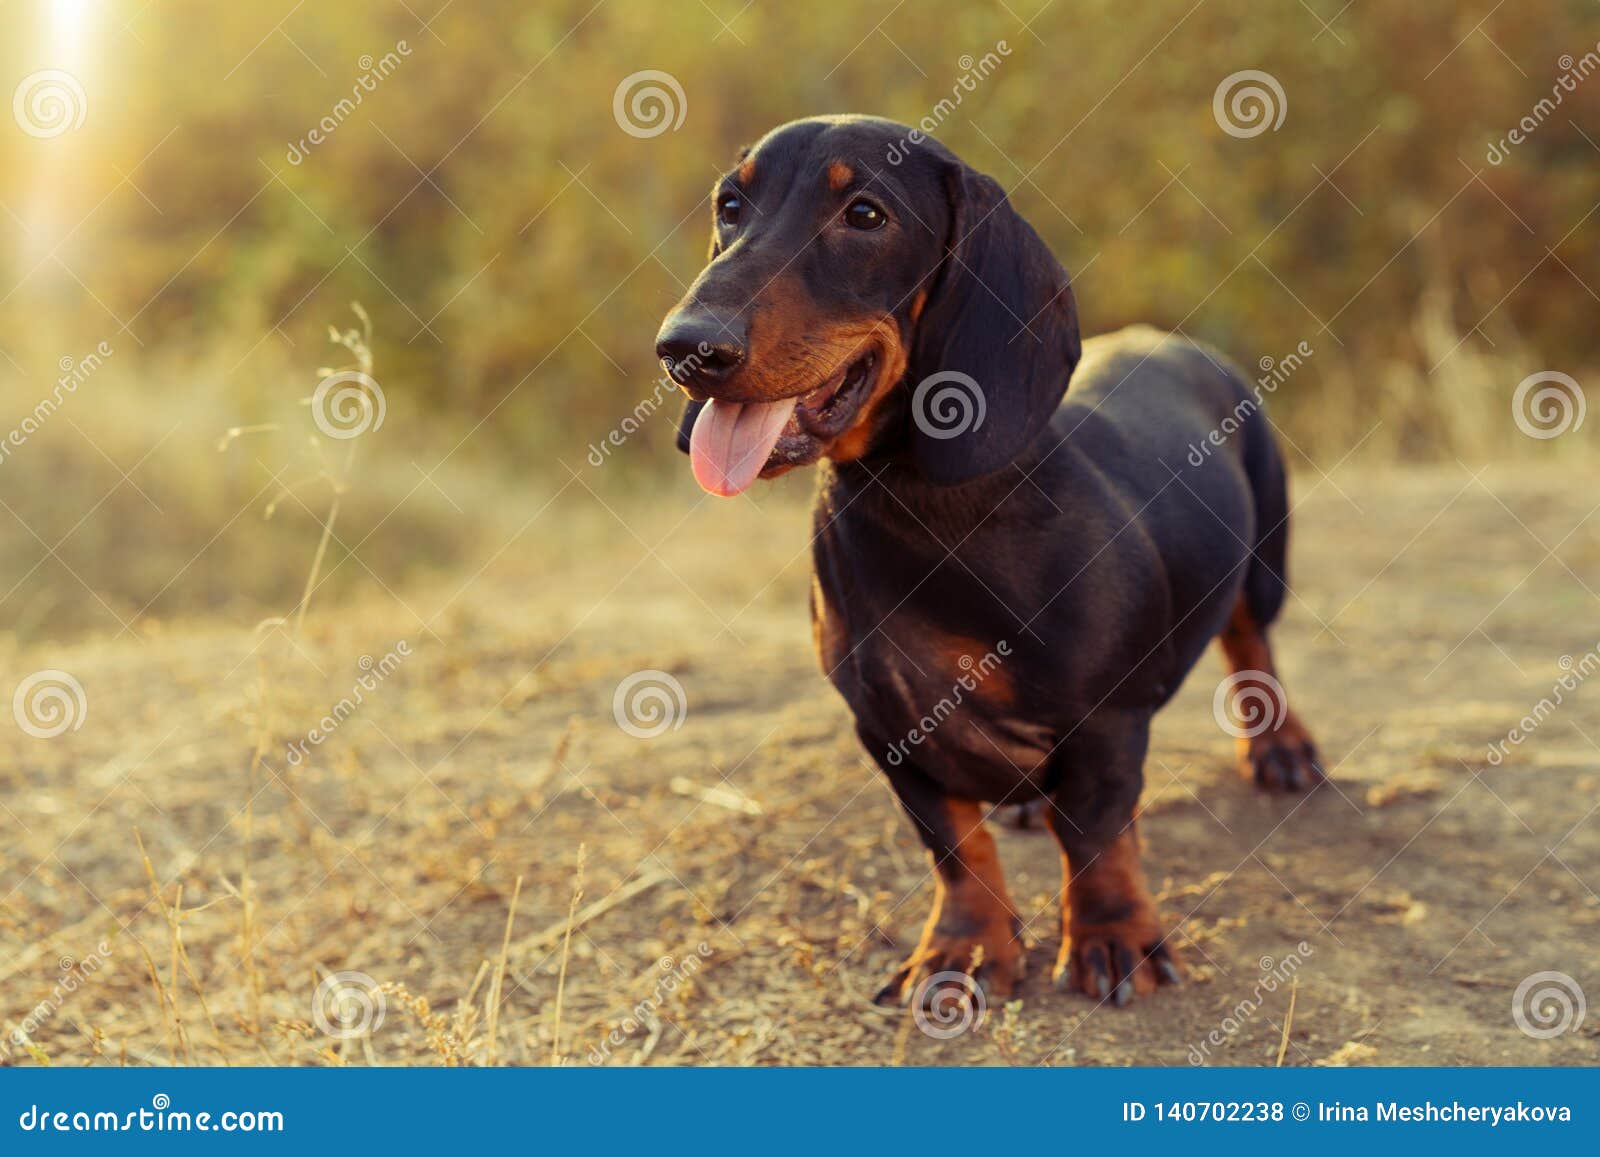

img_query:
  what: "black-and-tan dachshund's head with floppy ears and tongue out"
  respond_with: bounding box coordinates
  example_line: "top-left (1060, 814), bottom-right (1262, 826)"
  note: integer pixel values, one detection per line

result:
top-left (656, 117), bottom-right (1078, 496)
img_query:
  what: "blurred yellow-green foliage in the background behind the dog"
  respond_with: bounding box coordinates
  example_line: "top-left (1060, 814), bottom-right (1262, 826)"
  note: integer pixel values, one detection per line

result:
top-left (0, 0), bottom-right (1600, 633)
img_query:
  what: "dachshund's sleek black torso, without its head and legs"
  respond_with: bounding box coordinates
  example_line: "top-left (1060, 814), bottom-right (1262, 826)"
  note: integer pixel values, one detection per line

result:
top-left (813, 328), bottom-right (1285, 800)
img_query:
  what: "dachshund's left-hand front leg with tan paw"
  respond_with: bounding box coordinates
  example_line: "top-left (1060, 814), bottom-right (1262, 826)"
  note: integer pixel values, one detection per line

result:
top-left (869, 744), bottom-right (1026, 1005)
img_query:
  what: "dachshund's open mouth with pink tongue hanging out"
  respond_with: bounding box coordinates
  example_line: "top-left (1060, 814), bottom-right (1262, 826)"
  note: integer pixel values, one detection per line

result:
top-left (690, 349), bottom-right (878, 498)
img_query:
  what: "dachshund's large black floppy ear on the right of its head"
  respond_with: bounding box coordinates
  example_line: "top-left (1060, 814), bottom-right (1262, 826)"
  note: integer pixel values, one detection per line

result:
top-left (906, 162), bottom-right (1080, 486)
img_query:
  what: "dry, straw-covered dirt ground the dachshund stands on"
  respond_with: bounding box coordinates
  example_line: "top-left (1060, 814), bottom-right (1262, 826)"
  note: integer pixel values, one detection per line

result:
top-left (0, 466), bottom-right (1600, 1066)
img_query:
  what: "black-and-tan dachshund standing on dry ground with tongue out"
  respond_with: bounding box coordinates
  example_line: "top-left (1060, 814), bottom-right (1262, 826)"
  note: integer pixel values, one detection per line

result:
top-left (656, 117), bottom-right (1323, 1005)
